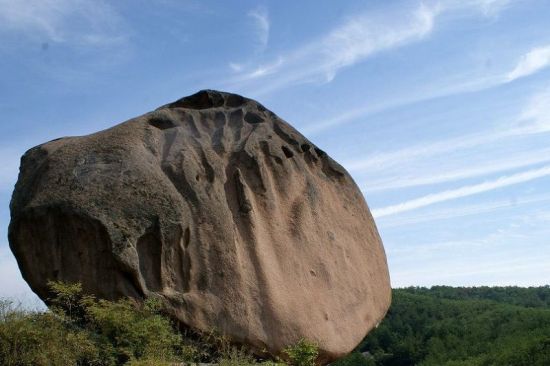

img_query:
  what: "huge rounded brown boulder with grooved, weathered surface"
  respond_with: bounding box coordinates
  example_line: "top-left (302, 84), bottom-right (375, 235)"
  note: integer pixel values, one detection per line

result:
top-left (9, 90), bottom-right (391, 361)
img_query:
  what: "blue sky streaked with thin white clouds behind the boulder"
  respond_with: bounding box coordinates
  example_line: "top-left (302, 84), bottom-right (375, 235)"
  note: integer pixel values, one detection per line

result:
top-left (0, 0), bottom-right (550, 299)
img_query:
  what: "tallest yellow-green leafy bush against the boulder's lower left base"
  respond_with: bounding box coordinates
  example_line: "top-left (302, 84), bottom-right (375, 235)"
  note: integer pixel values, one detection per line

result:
top-left (50, 283), bottom-right (190, 365)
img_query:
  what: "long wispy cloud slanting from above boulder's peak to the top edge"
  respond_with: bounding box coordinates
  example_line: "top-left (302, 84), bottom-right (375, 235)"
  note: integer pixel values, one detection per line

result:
top-left (228, 0), bottom-right (509, 95)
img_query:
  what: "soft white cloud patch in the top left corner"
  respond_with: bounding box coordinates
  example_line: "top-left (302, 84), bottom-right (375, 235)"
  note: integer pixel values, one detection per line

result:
top-left (0, 0), bottom-right (126, 46)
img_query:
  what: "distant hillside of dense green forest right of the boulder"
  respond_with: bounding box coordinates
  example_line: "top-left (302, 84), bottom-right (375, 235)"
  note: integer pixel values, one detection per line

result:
top-left (338, 286), bottom-right (550, 366)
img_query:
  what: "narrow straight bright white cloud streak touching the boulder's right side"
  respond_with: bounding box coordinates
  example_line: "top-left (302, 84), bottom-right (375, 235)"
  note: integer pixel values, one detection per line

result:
top-left (372, 165), bottom-right (550, 218)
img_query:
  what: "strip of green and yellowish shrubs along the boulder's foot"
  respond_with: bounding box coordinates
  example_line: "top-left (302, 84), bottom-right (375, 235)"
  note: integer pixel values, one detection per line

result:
top-left (0, 282), bottom-right (317, 366)
